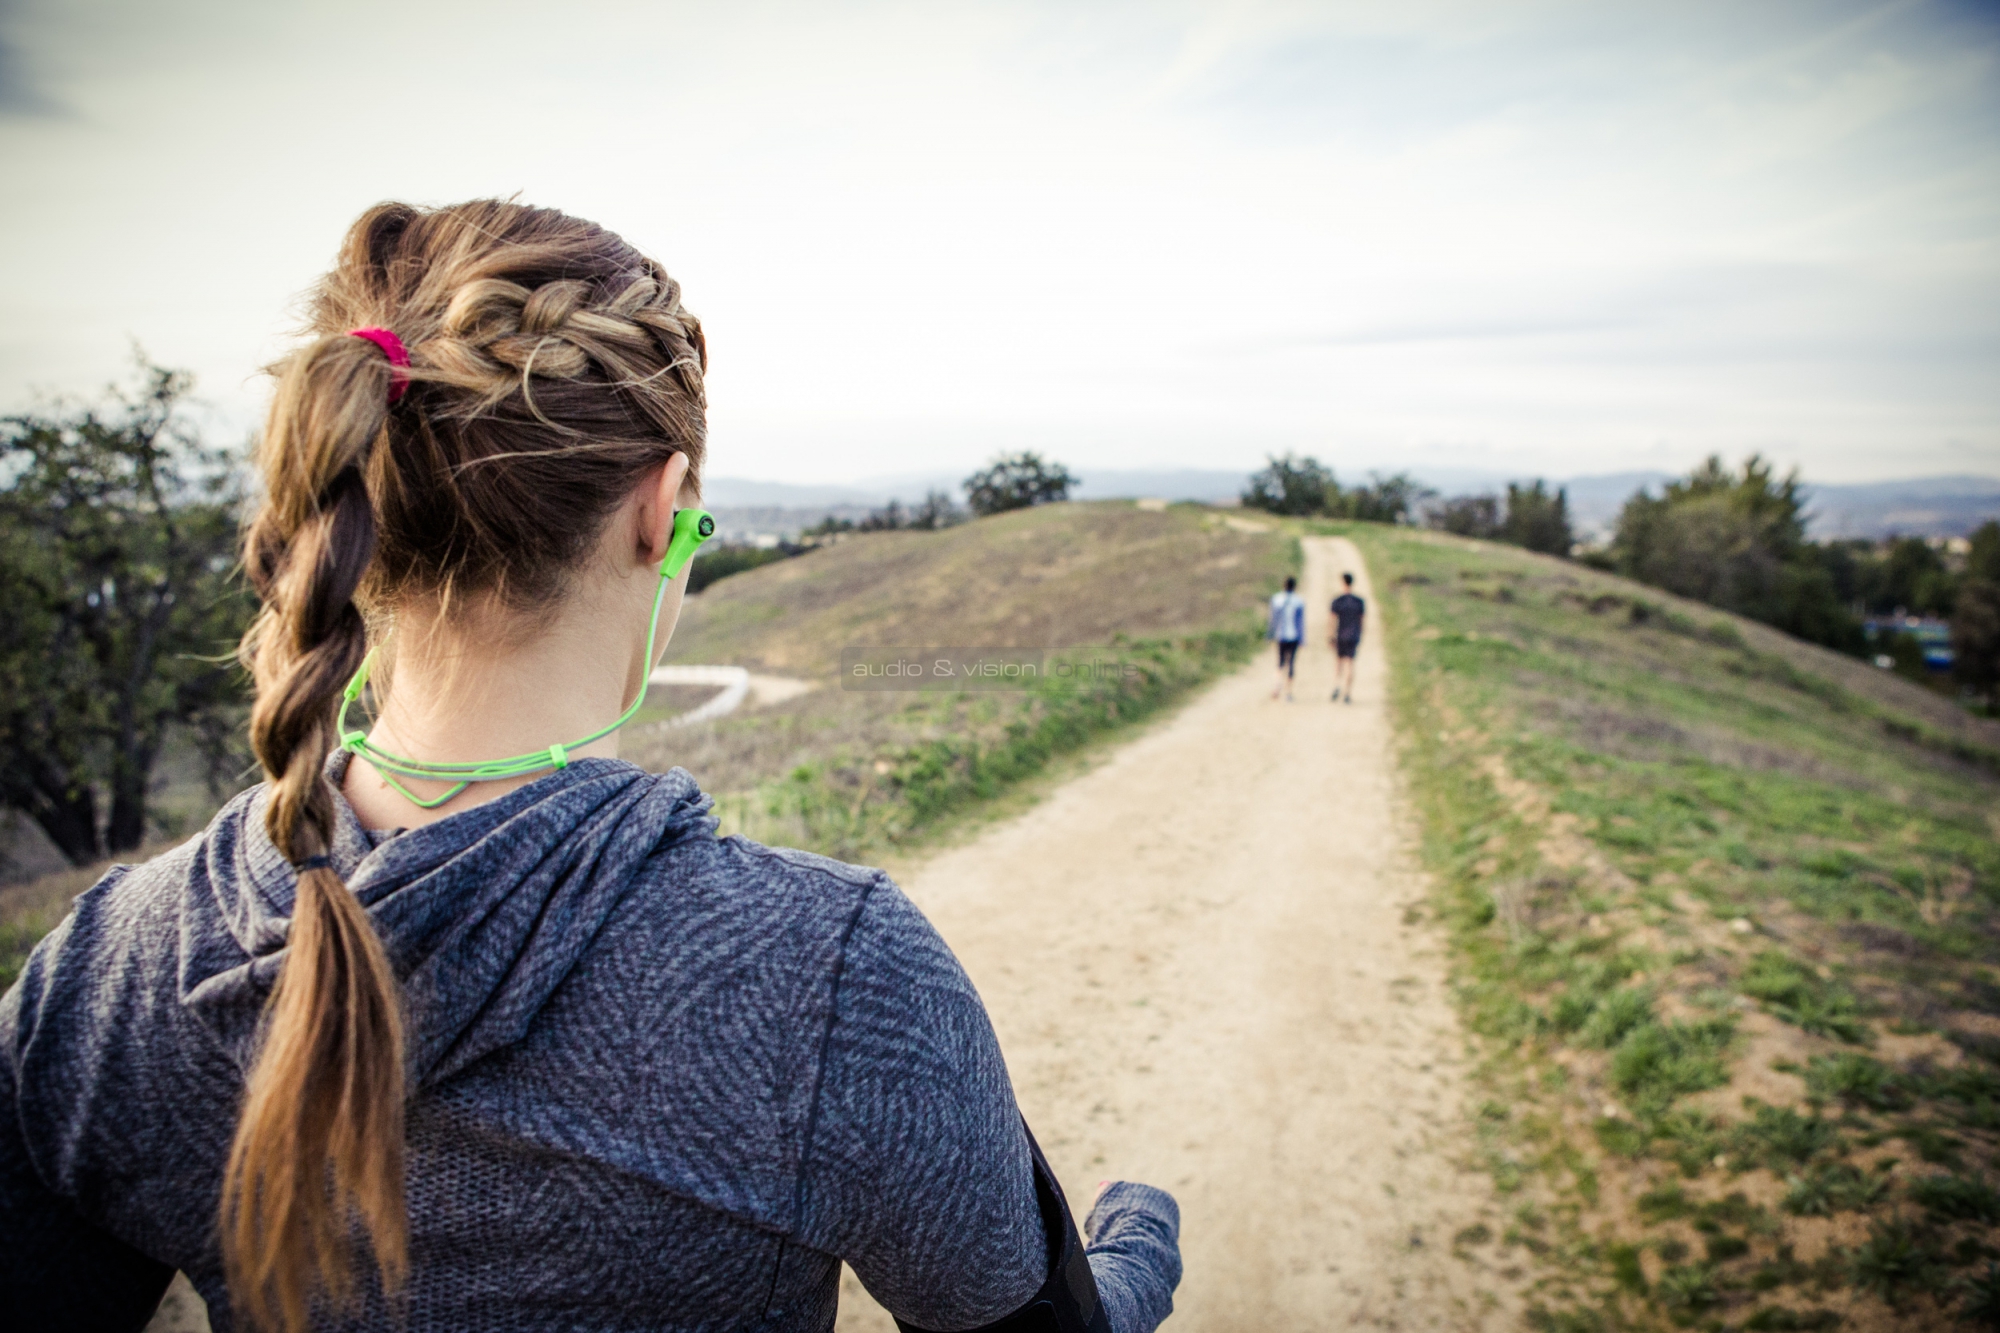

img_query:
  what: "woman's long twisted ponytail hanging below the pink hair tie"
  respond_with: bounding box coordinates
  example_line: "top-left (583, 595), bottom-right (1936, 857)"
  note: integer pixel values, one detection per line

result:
top-left (220, 324), bottom-right (408, 1333)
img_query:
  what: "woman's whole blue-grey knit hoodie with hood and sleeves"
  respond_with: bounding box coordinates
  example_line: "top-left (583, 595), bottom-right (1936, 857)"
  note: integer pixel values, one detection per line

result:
top-left (0, 759), bottom-right (1180, 1333)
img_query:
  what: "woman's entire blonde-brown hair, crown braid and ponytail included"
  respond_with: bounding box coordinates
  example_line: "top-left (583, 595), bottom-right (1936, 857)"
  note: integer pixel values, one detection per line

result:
top-left (231, 200), bottom-right (708, 1333)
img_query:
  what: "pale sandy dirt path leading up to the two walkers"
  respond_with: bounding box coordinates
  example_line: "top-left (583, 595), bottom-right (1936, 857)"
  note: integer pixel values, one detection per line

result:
top-left (838, 538), bottom-right (1514, 1333)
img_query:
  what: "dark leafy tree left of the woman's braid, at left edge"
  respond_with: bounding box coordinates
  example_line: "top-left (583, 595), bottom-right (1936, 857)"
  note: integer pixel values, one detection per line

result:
top-left (0, 360), bottom-right (250, 865)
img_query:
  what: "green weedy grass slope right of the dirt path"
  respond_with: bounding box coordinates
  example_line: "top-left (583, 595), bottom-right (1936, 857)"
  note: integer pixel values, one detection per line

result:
top-left (1340, 524), bottom-right (2000, 1329)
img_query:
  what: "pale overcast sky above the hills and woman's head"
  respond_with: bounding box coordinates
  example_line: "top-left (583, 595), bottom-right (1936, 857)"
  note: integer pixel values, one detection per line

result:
top-left (0, 0), bottom-right (2000, 482)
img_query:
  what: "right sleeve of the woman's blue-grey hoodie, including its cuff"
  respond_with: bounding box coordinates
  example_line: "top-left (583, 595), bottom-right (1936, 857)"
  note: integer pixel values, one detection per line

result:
top-left (802, 879), bottom-right (1180, 1333)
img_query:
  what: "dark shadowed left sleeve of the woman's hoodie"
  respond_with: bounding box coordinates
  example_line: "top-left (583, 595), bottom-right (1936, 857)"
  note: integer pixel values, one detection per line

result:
top-left (0, 929), bottom-right (174, 1333)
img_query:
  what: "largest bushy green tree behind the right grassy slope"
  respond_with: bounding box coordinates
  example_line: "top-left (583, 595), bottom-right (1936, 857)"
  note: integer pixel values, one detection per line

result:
top-left (1612, 456), bottom-right (1862, 652)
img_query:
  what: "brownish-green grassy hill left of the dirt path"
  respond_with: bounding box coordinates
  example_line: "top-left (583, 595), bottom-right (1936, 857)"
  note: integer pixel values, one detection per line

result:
top-left (626, 500), bottom-right (1298, 857)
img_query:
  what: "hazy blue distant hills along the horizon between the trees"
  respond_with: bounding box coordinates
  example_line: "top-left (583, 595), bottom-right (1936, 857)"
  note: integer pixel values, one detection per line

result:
top-left (704, 468), bottom-right (2000, 540)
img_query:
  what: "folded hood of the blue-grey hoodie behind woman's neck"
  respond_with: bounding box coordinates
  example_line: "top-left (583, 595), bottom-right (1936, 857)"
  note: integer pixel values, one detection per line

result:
top-left (178, 755), bottom-right (716, 1087)
